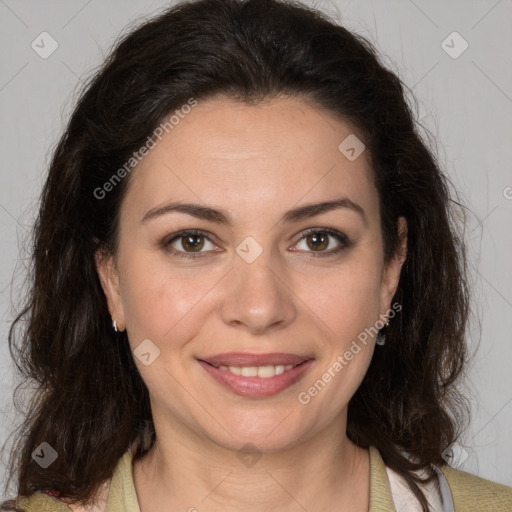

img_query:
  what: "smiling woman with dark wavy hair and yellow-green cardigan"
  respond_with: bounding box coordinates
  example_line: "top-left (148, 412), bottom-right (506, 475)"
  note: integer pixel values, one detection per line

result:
top-left (3, 0), bottom-right (512, 512)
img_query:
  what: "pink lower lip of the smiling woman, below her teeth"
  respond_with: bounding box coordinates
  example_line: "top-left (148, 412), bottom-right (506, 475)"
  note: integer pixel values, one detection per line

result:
top-left (198, 359), bottom-right (313, 398)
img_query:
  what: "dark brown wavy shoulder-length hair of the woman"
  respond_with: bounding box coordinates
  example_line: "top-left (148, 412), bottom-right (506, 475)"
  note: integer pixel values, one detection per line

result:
top-left (3, 0), bottom-right (469, 512)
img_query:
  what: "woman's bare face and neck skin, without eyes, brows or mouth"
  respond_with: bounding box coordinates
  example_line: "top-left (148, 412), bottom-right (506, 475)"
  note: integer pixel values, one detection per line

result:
top-left (97, 97), bottom-right (406, 512)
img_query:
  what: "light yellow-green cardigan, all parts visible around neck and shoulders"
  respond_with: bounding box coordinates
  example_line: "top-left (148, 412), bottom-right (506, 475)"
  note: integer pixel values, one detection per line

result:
top-left (17, 446), bottom-right (512, 512)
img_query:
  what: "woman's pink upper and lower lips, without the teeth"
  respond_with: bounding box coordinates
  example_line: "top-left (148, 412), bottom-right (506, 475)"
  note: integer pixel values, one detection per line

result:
top-left (198, 354), bottom-right (314, 398)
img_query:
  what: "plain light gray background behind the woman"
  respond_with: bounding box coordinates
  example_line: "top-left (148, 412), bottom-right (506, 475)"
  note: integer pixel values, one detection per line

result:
top-left (0, 0), bottom-right (512, 496)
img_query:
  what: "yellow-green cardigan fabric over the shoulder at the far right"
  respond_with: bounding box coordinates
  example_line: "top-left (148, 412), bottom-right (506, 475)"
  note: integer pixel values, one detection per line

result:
top-left (440, 465), bottom-right (512, 512)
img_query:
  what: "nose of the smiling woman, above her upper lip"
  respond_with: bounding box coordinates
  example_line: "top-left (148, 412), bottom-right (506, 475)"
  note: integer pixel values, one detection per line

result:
top-left (222, 251), bottom-right (297, 335)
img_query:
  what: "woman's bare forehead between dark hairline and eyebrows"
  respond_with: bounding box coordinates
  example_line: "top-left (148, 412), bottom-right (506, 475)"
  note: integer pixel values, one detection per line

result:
top-left (119, 97), bottom-right (378, 226)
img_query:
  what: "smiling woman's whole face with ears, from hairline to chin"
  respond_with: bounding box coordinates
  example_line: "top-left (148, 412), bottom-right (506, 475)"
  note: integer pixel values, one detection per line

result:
top-left (97, 98), bottom-right (403, 452)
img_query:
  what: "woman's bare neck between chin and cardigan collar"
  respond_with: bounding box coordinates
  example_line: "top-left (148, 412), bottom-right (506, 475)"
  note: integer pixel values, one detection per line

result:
top-left (133, 416), bottom-right (370, 512)
